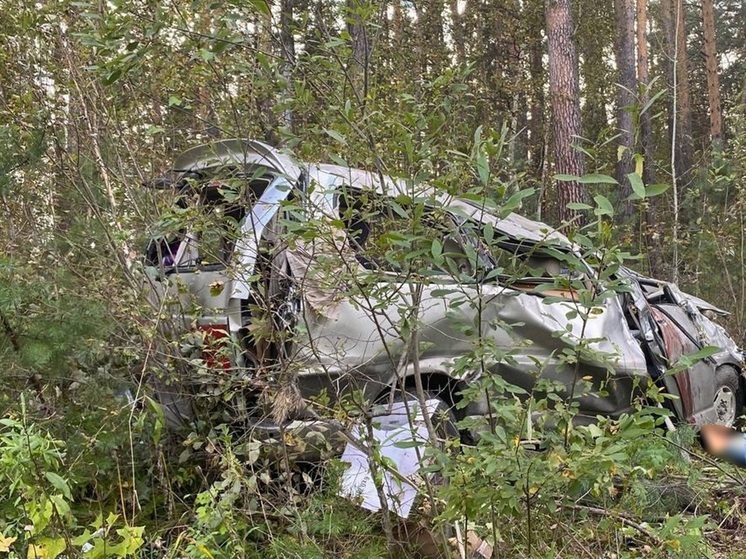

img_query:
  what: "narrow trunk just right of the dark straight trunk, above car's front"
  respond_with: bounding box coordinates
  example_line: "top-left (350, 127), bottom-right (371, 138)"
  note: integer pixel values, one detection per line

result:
top-left (637, 0), bottom-right (663, 278)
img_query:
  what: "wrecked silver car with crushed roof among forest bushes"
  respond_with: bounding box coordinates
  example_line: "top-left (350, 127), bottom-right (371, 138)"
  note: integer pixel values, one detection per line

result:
top-left (145, 140), bottom-right (744, 446)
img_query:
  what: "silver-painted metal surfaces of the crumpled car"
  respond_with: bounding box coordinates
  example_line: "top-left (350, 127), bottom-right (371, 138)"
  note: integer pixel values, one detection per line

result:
top-left (144, 141), bottom-right (739, 428)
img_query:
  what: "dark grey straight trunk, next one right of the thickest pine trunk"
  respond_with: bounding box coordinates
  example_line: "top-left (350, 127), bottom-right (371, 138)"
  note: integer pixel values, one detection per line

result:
top-left (614, 0), bottom-right (637, 219)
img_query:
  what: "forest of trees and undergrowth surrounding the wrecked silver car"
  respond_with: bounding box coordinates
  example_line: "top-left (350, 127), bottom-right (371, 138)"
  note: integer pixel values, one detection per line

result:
top-left (0, 0), bottom-right (746, 557)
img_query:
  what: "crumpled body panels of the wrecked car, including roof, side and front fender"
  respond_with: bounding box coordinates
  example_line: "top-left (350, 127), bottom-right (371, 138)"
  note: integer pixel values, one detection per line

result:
top-left (142, 140), bottom-right (741, 434)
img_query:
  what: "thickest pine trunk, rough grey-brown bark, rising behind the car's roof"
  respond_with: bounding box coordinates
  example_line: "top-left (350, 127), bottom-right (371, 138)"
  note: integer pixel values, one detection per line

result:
top-left (545, 0), bottom-right (586, 225)
